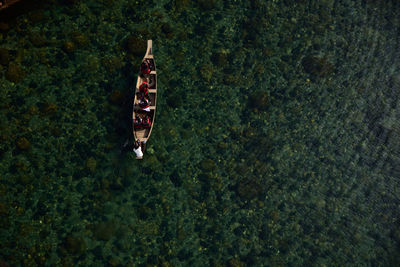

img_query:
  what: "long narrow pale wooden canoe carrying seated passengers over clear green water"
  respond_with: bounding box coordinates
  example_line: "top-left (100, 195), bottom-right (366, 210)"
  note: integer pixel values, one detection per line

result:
top-left (132, 40), bottom-right (157, 159)
